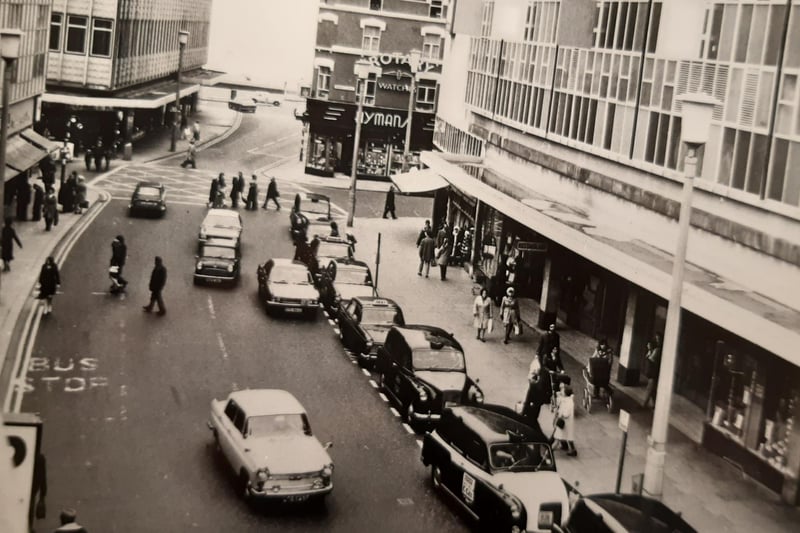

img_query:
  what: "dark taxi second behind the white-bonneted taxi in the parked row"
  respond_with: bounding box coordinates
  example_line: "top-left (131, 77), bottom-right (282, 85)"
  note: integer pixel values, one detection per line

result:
top-left (336, 296), bottom-right (405, 366)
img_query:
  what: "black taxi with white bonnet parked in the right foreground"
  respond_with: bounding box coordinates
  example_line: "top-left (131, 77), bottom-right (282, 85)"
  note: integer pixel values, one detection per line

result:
top-left (422, 405), bottom-right (569, 532)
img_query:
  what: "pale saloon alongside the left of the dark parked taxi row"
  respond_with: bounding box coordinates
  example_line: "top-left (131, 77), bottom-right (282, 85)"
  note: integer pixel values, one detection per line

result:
top-left (256, 258), bottom-right (319, 319)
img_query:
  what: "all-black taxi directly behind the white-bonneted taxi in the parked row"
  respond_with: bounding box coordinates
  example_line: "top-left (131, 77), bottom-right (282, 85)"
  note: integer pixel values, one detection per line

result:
top-left (375, 325), bottom-right (483, 425)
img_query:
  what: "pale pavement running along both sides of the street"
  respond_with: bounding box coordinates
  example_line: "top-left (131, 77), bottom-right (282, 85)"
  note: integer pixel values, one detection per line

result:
top-left (0, 87), bottom-right (800, 532)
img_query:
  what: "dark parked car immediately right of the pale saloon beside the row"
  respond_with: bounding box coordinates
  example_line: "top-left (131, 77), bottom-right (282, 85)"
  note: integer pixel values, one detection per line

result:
top-left (316, 258), bottom-right (375, 315)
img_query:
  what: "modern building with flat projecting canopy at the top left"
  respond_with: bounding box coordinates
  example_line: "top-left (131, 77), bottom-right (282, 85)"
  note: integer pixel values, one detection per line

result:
top-left (38, 0), bottom-right (217, 157)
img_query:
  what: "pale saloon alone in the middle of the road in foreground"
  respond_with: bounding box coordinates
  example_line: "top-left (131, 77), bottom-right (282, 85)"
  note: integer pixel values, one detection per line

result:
top-left (208, 389), bottom-right (333, 502)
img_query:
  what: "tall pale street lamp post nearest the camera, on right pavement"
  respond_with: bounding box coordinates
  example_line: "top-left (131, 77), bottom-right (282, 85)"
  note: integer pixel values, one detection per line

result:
top-left (643, 94), bottom-right (719, 499)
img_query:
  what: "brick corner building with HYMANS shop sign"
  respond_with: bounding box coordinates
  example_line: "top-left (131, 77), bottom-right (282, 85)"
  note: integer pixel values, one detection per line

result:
top-left (304, 0), bottom-right (450, 179)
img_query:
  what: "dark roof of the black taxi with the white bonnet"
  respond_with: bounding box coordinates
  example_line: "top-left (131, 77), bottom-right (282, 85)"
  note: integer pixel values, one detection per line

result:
top-left (444, 405), bottom-right (547, 444)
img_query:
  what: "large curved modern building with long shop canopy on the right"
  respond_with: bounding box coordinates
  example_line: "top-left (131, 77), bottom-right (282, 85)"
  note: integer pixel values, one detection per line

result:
top-left (428, 0), bottom-right (800, 504)
